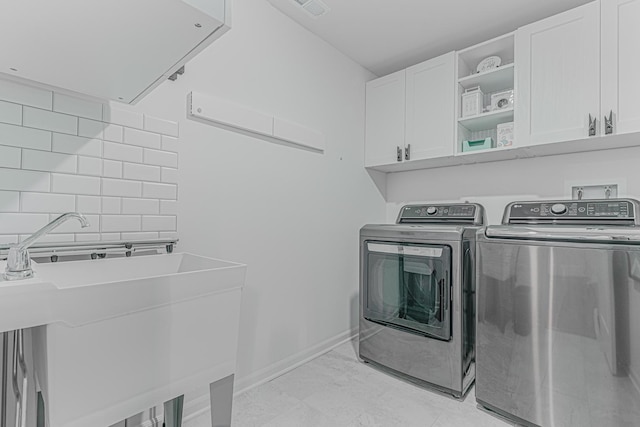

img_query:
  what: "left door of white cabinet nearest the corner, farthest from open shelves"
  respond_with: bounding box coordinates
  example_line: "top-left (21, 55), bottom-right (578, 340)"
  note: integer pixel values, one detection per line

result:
top-left (364, 70), bottom-right (405, 166)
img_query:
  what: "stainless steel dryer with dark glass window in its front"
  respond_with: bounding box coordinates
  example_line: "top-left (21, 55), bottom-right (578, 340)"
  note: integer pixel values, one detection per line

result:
top-left (359, 203), bottom-right (485, 398)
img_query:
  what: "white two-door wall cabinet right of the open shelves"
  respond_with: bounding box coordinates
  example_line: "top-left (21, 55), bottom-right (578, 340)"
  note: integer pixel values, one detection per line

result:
top-left (516, 0), bottom-right (640, 146)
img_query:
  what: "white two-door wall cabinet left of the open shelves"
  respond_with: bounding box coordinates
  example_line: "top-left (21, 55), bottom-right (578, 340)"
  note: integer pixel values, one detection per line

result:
top-left (365, 52), bottom-right (455, 170)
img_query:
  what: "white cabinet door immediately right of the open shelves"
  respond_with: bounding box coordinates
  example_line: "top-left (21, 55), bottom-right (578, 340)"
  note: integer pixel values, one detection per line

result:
top-left (515, 2), bottom-right (600, 145)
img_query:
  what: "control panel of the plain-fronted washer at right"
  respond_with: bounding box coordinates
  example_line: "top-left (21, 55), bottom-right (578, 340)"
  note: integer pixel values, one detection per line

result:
top-left (503, 199), bottom-right (637, 224)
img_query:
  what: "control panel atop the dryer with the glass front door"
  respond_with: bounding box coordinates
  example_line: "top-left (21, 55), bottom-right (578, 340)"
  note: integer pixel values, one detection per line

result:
top-left (397, 203), bottom-right (484, 224)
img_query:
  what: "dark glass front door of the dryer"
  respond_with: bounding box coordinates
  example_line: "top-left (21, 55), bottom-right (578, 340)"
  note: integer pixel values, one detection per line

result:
top-left (363, 241), bottom-right (451, 341)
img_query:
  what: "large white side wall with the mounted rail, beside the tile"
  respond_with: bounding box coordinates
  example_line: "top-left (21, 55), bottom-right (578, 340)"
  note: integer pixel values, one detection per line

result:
top-left (133, 0), bottom-right (385, 402)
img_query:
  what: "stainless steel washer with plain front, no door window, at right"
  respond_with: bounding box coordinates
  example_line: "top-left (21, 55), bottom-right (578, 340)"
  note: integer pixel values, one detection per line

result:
top-left (476, 199), bottom-right (640, 427)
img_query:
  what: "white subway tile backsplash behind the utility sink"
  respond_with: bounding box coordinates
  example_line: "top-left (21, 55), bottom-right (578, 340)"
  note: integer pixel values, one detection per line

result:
top-left (0, 80), bottom-right (179, 243)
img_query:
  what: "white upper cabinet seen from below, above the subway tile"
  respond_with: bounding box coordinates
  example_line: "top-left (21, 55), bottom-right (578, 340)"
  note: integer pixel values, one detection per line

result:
top-left (0, 0), bottom-right (230, 103)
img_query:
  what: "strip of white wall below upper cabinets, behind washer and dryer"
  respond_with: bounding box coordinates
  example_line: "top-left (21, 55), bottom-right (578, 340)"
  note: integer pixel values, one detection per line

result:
top-left (386, 142), bottom-right (640, 224)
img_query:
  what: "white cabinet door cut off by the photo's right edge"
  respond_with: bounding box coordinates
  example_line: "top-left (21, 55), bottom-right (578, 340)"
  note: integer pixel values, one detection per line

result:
top-left (601, 0), bottom-right (640, 135)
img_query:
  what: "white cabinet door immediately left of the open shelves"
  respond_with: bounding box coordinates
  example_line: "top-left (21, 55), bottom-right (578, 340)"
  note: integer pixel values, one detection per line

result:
top-left (405, 52), bottom-right (455, 160)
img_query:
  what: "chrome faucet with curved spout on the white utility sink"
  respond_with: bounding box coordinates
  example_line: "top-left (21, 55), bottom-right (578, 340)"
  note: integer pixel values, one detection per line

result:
top-left (4, 212), bottom-right (89, 280)
